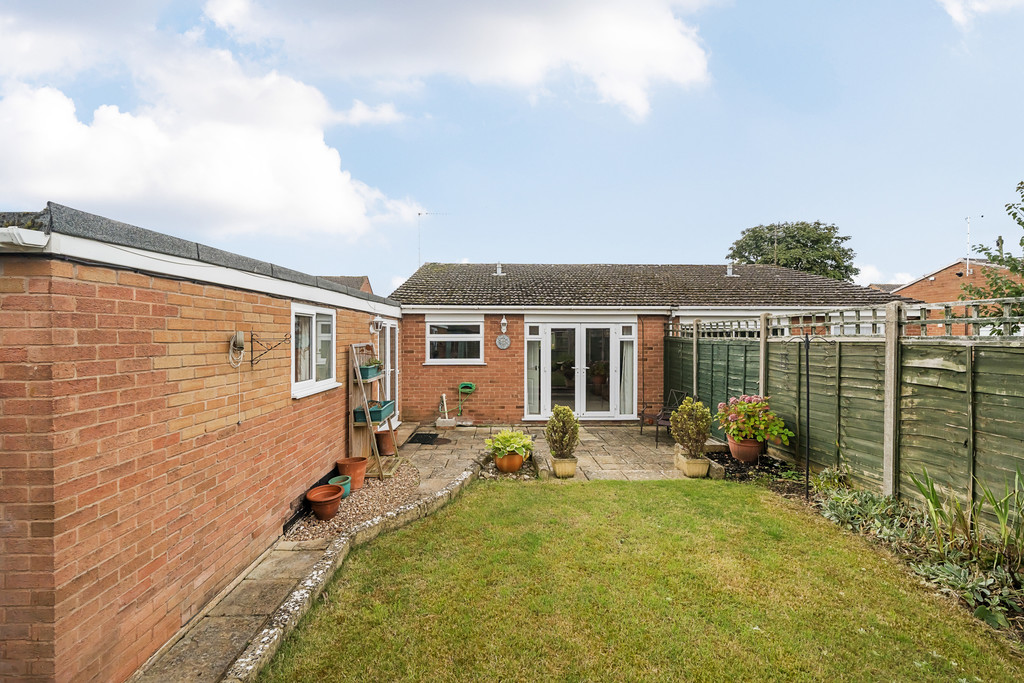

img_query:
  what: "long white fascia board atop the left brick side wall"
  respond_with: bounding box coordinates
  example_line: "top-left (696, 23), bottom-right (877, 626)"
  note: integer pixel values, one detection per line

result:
top-left (42, 232), bottom-right (401, 317)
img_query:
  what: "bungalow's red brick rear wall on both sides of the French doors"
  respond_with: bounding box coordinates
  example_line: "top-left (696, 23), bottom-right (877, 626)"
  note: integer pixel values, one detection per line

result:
top-left (400, 314), bottom-right (669, 424)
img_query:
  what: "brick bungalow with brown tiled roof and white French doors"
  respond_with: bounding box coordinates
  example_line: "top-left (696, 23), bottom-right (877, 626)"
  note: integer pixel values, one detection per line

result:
top-left (391, 263), bottom-right (897, 423)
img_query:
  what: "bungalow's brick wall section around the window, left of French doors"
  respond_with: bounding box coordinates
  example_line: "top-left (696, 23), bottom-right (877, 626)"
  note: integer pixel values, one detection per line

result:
top-left (398, 314), bottom-right (525, 424)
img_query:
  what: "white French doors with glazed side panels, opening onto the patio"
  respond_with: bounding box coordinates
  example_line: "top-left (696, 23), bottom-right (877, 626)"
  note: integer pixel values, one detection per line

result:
top-left (526, 323), bottom-right (636, 419)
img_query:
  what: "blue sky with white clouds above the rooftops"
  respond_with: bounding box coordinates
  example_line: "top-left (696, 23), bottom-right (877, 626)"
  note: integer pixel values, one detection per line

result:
top-left (0, 0), bottom-right (1024, 295)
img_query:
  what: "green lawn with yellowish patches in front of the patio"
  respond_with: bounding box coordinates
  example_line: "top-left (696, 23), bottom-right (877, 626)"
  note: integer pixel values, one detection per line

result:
top-left (261, 480), bottom-right (1024, 681)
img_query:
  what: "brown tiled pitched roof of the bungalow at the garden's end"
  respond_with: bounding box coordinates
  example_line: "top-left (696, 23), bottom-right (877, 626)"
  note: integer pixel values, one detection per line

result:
top-left (391, 263), bottom-right (913, 307)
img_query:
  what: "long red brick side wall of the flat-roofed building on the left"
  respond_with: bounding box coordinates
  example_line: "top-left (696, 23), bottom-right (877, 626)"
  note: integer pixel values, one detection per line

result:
top-left (0, 258), bottom-right (393, 681)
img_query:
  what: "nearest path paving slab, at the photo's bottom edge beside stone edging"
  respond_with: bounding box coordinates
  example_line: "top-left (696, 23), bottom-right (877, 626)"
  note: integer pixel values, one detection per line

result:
top-left (137, 616), bottom-right (266, 683)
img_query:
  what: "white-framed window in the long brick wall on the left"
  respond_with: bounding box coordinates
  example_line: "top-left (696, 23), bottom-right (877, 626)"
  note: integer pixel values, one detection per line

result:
top-left (292, 303), bottom-right (339, 398)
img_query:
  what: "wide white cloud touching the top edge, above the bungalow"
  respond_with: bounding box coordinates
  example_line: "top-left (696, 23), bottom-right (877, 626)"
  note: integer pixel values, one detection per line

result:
top-left (205, 0), bottom-right (708, 120)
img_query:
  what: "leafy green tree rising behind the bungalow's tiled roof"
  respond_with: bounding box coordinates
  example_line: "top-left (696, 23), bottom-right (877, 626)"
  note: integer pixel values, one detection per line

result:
top-left (726, 220), bottom-right (860, 280)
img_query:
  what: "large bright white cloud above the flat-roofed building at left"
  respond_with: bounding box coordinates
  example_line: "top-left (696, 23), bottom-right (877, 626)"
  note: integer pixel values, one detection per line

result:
top-left (0, 41), bottom-right (421, 236)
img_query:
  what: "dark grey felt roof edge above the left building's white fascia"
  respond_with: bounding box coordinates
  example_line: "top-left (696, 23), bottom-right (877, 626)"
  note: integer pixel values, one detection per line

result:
top-left (8, 202), bottom-right (397, 306)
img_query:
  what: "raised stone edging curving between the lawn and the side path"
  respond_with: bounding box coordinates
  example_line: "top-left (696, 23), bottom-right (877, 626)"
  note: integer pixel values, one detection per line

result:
top-left (220, 460), bottom-right (481, 683)
